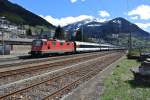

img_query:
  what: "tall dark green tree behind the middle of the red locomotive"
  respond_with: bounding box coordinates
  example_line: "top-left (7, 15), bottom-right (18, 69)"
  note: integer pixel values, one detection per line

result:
top-left (54, 26), bottom-right (64, 39)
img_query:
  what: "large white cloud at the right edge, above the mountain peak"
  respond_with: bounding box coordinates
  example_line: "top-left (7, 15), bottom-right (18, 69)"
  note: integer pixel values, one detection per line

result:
top-left (128, 5), bottom-right (150, 20)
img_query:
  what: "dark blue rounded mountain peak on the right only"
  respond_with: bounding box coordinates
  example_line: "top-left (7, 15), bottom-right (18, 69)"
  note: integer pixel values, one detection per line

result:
top-left (104, 17), bottom-right (150, 37)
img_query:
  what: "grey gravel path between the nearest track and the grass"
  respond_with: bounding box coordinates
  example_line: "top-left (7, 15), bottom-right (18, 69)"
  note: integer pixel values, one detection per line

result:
top-left (62, 56), bottom-right (125, 100)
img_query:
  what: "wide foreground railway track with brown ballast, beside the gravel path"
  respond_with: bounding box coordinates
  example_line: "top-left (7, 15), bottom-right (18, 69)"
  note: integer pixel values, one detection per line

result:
top-left (0, 53), bottom-right (121, 100)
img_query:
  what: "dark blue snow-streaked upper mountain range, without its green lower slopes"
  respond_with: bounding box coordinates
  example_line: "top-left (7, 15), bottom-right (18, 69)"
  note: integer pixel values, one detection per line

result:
top-left (64, 17), bottom-right (150, 38)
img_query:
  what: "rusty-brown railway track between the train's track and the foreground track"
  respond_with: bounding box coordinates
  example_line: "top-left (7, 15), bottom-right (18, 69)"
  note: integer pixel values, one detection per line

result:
top-left (0, 52), bottom-right (113, 85)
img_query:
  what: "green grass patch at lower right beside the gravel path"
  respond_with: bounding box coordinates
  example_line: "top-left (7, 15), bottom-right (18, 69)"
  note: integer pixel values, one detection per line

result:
top-left (101, 58), bottom-right (150, 100)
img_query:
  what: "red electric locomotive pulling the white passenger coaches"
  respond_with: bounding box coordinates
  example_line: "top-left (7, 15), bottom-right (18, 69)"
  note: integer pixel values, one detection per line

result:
top-left (31, 39), bottom-right (75, 56)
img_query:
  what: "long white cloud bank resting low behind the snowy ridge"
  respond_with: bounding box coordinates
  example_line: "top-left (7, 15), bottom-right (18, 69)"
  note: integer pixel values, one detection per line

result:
top-left (40, 15), bottom-right (94, 26)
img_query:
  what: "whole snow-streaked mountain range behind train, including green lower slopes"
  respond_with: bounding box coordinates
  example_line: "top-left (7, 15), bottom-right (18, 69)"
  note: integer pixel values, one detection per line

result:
top-left (64, 17), bottom-right (150, 45)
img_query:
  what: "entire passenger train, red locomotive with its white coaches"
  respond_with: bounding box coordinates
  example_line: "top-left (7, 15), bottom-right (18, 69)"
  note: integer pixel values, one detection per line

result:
top-left (30, 39), bottom-right (120, 56)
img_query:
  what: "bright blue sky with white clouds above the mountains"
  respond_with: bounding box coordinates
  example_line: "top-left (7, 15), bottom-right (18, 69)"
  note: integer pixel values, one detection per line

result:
top-left (9, 0), bottom-right (150, 32)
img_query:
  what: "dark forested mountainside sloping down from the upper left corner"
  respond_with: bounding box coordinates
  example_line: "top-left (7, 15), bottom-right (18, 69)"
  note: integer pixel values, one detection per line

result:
top-left (0, 0), bottom-right (54, 27)
